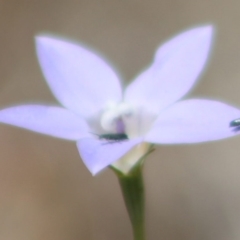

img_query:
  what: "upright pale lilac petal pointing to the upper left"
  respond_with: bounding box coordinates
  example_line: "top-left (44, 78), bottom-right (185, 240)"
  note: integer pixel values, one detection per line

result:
top-left (36, 36), bottom-right (122, 117)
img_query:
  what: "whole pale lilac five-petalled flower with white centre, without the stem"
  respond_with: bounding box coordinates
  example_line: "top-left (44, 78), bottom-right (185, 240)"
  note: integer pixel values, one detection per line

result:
top-left (0, 26), bottom-right (240, 174)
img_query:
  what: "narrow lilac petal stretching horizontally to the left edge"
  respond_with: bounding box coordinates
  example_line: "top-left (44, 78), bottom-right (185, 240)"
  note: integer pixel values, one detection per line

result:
top-left (0, 105), bottom-right (89, 140)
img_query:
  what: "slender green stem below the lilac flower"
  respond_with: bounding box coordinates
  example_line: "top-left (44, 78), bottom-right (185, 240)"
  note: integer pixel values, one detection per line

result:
top-left (118, 166), bottom-right (145, 240)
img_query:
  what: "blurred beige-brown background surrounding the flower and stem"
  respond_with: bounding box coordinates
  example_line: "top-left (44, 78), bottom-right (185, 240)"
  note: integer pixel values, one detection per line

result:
top-left (0, 0), bottom-right (240, 240)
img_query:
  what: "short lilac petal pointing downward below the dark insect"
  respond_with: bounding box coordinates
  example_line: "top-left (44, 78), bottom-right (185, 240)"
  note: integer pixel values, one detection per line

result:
top-left (77, 138), bottom-right (142, 175)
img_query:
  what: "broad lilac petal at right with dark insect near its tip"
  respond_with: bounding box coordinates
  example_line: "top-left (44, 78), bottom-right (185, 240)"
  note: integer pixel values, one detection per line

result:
top-left (145, 99), bottom-right (240, 144)
